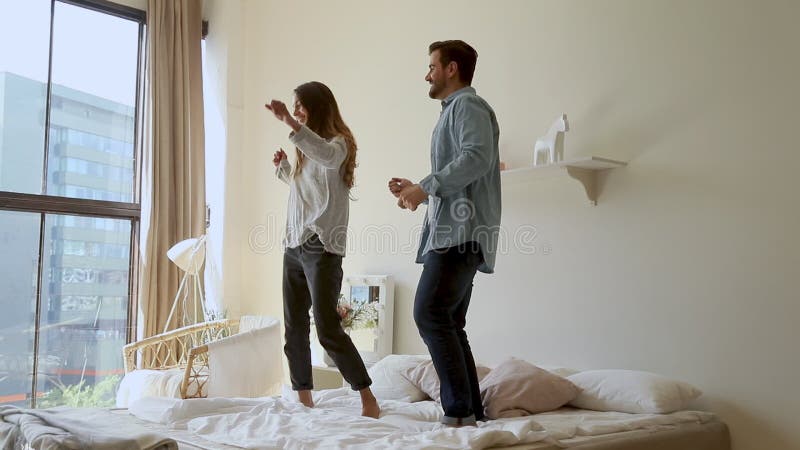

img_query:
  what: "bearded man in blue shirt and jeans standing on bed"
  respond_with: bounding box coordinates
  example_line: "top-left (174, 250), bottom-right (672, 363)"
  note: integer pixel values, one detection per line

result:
top-left (389, 41), bottom-right (500, 426)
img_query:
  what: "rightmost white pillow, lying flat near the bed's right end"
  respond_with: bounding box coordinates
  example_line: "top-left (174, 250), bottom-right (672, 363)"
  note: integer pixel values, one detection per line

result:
top-left (567, 370), bottom-right (702, 414)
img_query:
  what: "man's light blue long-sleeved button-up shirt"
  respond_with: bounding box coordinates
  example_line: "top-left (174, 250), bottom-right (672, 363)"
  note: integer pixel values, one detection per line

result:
top-left (417, 86), bottom-right (501, 273)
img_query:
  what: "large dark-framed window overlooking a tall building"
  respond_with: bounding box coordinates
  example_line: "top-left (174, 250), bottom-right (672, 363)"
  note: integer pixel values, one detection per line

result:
top-left (0, 0), bottom-right (145, 407)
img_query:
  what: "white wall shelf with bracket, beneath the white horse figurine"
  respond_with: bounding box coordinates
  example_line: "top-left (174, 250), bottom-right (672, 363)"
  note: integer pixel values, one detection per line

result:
top-left (500, 156), bottom-right (627, 205)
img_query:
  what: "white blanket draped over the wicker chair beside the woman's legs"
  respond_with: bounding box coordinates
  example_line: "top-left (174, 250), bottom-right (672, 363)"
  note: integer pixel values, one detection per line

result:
top-left (208, 319), bottom-right (283, 397)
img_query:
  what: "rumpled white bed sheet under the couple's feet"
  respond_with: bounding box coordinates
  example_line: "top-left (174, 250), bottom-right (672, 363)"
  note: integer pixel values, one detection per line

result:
top-left (130, 388), bottom-right (715, 450)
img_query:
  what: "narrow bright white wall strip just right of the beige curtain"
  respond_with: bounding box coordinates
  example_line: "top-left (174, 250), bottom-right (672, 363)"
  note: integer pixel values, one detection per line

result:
top-left (203, 0), bottom-right (247, 317)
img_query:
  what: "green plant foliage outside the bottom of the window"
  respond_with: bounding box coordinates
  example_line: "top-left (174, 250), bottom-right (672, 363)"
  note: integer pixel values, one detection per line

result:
top-left (36, 375), bottom-right (122, 408)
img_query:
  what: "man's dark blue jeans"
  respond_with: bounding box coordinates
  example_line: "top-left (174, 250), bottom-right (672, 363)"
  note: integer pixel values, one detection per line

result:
top-left (414, 242), bottom-right (485, 424)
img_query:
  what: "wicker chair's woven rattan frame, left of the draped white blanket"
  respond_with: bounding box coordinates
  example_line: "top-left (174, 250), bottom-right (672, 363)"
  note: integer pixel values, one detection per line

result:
top-left (122, 319), bottom-right (239, 399)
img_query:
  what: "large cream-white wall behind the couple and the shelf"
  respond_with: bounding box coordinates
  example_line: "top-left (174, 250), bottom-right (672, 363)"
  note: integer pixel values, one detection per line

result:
top-left (210, 0), bottom-right (800, 450)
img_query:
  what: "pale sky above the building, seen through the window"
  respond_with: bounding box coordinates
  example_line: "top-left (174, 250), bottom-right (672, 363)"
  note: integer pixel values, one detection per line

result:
top-left (0, 0), bottom-right (139, 106)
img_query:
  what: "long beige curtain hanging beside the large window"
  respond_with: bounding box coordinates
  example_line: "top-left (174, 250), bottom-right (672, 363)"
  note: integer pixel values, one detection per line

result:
top-left (138, 0), bottom-right (206, 338)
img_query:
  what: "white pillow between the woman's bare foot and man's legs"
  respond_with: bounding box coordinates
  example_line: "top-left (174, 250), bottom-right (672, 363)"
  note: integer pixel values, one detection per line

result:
top-left (368, 355), bottom-right (430, 402)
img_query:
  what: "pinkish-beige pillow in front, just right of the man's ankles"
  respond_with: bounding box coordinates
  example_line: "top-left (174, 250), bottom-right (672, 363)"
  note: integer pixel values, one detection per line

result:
top-left (481, 358), bottom-right (580, 419)
